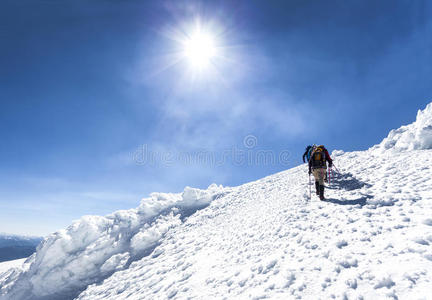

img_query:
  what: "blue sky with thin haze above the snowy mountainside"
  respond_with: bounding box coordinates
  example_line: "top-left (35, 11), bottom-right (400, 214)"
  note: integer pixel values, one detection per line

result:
top-left (0, 0), bottom-right (432, 235)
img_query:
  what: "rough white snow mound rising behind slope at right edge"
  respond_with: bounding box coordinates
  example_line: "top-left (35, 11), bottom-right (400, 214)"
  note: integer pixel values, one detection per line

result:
top-left (371, 103), bottom-right (432, 152)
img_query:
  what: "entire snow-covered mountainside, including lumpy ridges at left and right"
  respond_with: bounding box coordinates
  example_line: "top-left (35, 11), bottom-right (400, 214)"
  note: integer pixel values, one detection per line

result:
top-left (0, 105), bottom-right (432, 299)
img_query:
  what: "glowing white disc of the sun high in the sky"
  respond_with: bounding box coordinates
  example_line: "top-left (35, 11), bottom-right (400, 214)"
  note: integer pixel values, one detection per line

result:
top-left (183, 31), bottom-right (217, 69)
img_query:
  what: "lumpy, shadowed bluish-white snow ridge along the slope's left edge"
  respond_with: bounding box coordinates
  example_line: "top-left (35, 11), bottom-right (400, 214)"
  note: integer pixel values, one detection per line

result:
top-left (0, 184), bottom-right (226, 299)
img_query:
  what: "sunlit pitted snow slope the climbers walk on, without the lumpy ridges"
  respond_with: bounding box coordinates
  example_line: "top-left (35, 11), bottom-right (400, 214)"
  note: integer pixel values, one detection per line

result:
top-left (78, 150), bottom-right (432, 299)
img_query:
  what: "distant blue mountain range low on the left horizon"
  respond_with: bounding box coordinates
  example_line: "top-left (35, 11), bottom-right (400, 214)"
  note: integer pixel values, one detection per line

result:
top-left (0, 234), bottom-right (42, 262)
